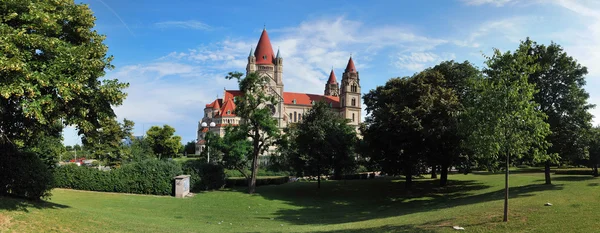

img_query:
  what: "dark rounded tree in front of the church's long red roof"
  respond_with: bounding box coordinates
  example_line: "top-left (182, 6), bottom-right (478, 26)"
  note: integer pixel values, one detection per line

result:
top-left (294, 101), bottom-right (358, 188)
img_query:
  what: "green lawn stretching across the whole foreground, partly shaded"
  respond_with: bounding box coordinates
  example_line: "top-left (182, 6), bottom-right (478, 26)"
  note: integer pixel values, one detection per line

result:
top-left (0, 173), bottom-right (600, 232)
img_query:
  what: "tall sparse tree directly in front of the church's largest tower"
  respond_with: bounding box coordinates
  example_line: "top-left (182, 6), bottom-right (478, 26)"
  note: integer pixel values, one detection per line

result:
top-left (226, 72), bottom-right (280, 194)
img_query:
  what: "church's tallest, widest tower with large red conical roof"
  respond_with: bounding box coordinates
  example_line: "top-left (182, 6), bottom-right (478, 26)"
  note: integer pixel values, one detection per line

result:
top-left (246, 29), bottom-right (285, 127)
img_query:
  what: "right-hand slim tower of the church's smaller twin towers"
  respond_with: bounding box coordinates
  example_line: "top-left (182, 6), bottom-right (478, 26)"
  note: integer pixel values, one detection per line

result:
top-left (340, 57), bottom-right (362, 129)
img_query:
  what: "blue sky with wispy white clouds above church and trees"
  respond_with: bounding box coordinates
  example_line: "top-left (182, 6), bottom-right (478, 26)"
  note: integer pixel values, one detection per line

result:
top-left (63, 0), bottom-right (600, 145)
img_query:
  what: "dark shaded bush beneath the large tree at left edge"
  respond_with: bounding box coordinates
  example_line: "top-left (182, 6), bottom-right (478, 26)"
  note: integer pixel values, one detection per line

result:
top-left (0, 146), bottom-right (53, 200)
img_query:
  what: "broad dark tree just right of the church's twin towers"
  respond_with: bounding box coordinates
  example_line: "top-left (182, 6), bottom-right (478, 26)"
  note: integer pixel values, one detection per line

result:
top-left (362, 69), bottom-right (461, 188)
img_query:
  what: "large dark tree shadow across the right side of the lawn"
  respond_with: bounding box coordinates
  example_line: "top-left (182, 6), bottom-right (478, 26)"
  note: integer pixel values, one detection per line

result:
top-left (246, 179), bottom-right (562, 226)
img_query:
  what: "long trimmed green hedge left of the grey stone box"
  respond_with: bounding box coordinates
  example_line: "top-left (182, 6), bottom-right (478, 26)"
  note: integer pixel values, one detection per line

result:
top-left (54, 159), bottom-right (182, 195)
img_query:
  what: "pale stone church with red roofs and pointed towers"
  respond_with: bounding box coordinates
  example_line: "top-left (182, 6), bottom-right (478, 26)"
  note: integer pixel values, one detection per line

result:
top-left (196, 29), bottom-right (362, 154)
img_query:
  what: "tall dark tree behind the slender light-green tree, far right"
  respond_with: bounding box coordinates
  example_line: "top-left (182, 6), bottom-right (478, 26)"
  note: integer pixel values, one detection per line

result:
top-left (517, 38), bottom-right (594, 184)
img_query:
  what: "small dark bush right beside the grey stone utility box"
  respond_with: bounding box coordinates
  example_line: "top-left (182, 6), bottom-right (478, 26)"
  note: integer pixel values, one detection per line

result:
top-left (183, 160), bottom-right (225, 192)
